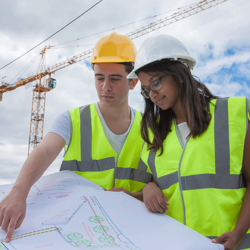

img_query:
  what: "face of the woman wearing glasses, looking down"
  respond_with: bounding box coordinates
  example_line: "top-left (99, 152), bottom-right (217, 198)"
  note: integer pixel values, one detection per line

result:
top-left (138, 72), bottom-right (180, 110)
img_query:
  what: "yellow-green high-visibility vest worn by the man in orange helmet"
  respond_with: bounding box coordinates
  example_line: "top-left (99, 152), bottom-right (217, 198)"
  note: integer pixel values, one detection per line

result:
top-left (60, 104), bottom-right (152, 192)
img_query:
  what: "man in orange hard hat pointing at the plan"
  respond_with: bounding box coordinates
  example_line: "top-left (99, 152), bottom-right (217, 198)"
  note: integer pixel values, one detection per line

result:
top-left (0, 33), bottom-right (152, 242)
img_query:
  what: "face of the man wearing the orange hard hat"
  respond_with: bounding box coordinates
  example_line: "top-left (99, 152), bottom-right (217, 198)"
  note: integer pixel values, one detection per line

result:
top-left (94, 63), bottom-right (135, 107)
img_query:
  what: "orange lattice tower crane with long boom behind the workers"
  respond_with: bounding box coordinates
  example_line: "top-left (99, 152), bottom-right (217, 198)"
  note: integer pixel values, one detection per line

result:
top-left (0, 0), bottom-right (228, 155)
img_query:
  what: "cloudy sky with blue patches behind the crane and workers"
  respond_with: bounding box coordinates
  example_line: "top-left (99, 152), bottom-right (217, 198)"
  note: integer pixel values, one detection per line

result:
top-left (0, 0), bottom-right (250, 185)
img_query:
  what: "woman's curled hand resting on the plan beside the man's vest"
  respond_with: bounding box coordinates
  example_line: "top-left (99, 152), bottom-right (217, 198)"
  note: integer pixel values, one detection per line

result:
top-left (142, 182), bottom-right (169, 213)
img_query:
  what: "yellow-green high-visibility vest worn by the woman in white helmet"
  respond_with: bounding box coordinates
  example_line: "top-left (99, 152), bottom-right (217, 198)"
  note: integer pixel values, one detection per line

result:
top-left (141, 97), bottom-right (250, 249)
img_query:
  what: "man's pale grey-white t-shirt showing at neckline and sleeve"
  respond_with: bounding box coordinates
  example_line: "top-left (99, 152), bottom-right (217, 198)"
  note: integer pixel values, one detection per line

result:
top-left (49, 103), bottom-right (135, 154)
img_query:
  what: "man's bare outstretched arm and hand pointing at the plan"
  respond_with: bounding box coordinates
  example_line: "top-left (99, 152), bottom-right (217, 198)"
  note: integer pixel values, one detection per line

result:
top-left (0, 133), bottom-right (65, 242)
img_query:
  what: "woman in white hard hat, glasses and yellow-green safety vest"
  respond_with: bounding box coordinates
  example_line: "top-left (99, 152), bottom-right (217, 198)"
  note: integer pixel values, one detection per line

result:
top-left (128, 35), bottom-right (250, 250)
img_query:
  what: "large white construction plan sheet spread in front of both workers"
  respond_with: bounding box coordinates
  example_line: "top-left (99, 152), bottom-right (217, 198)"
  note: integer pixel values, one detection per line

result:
top-left (0, 171), bottom-right (224, 250)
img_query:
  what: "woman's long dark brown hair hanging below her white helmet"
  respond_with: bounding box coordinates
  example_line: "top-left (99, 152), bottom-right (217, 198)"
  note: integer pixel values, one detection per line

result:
top-left (135, 60), bottom-right (218, 155)
